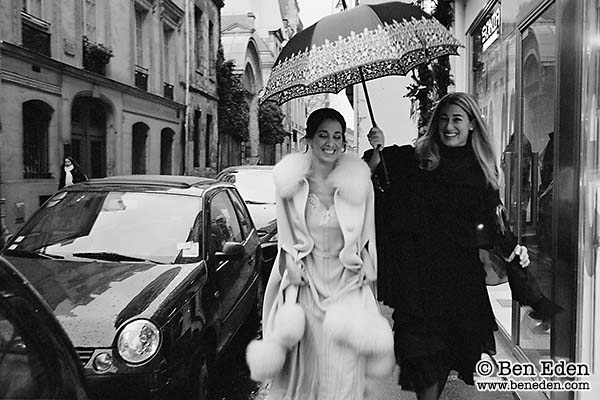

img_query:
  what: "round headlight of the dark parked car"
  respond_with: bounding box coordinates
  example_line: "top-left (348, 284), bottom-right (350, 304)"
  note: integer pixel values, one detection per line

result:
top-left (117, 319), bottom-right (160, 364)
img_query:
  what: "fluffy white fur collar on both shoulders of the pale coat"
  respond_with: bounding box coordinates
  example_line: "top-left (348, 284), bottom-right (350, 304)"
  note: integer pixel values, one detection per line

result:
top-left (273, 153), bottom-right (371, 204)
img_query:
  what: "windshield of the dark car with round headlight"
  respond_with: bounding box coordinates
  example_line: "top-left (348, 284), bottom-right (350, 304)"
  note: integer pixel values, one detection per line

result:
top-left (8, 191), bottom-right (202, 264)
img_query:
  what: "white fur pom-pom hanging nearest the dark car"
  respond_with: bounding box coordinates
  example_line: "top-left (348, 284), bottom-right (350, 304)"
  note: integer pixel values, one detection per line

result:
top-left (246, 339), bottom-right (286, 382)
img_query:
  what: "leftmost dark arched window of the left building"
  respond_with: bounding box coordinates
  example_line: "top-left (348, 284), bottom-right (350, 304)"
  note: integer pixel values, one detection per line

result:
top-left (23, 100), bottom-right (54, 178)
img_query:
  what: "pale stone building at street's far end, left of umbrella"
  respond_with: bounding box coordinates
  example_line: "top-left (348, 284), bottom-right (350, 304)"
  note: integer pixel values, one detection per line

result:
top-left (221, 0), bottom-right (308, 164)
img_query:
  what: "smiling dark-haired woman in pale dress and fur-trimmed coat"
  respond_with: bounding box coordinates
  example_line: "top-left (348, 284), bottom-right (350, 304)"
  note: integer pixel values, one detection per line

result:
top-left (247, 108), bottom-right (394, 400)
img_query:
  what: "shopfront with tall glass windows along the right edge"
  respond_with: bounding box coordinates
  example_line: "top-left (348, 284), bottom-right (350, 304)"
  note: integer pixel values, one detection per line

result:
top-left (452, 0), bottom-right (600, 399)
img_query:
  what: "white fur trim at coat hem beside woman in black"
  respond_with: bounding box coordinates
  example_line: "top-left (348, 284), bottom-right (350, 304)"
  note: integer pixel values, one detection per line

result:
top-left (323, 301), bottom-right (394, 355)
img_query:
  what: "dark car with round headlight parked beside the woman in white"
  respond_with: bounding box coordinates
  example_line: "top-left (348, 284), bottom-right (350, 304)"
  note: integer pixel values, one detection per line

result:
top-left (3, 175), bottom-right (260, 399)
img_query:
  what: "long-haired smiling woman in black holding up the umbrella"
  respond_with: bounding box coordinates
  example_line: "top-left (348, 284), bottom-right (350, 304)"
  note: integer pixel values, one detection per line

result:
top-left (364, 93), bottom-right (529, 400)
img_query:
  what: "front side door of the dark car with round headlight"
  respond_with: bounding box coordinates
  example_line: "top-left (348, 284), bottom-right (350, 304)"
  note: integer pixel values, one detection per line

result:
top-left (207, 188), bottom-right (257, 350)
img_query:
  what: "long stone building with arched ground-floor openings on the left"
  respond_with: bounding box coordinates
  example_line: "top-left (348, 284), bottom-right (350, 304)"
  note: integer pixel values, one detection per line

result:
top-left (0, 0), bottom-right (223, 238)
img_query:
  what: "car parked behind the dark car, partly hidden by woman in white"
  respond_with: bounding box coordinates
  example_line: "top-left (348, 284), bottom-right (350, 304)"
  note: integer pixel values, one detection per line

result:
top-left (217, 165), bottom-right (277, 286)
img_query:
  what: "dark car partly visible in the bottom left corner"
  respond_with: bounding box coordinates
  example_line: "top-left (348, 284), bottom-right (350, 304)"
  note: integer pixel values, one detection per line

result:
top-left (0, 257), bottom-right (88, 400)
